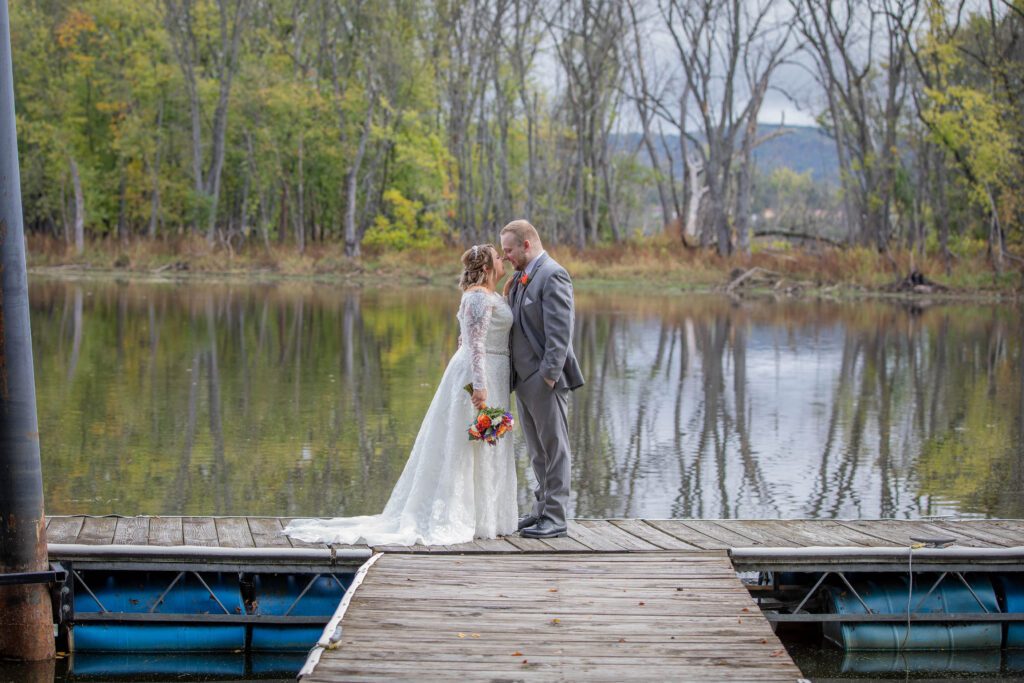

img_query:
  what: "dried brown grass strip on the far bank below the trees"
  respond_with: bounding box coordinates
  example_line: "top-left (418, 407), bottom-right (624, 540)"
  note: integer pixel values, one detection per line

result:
top-left (19, 236), bottom-right (1022, 291)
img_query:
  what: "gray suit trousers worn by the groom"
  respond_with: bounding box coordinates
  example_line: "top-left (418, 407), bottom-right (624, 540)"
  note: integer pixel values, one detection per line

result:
top-left (515, 372), bottom-right (572, 526)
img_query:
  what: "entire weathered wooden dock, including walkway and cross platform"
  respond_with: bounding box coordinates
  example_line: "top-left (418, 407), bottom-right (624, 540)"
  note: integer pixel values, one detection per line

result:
top-left (41, 516), bottom-right (1024, 681)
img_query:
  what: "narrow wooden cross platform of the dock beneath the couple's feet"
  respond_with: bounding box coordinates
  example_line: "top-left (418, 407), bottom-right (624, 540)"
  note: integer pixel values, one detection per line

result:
top-left (46, 515), bottom-right (1024, 553)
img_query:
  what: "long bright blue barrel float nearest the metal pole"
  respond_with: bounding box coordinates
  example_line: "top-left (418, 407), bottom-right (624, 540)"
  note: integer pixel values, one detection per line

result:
top-left (72, 570), bottom-right (246, 652)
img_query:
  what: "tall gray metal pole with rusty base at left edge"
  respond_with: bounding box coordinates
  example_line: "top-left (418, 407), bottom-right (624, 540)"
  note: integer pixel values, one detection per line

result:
top-left (0, 0), bottom-right (54, 661)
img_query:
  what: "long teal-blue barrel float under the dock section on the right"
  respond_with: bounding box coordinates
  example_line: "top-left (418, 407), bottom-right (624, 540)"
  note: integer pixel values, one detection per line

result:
top-left (824, 573), bottom-right (1002, 650)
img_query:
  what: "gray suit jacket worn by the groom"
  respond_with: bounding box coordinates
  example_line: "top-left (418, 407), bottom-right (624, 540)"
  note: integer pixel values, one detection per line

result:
top-left (509, 254), bottom-right (584, 390)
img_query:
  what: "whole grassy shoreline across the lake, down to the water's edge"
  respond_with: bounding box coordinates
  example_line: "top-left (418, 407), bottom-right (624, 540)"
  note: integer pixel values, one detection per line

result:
top-left (28, 238), bottom-right (1024, 301)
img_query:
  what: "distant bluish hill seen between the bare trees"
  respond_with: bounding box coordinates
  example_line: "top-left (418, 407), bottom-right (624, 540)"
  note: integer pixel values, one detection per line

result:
top-left (611, 125), bottom-right (839, 185)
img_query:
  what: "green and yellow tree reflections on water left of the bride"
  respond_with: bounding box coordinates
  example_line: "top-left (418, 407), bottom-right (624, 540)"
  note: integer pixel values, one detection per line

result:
top-left (32, 283), bottom-right (457, 515)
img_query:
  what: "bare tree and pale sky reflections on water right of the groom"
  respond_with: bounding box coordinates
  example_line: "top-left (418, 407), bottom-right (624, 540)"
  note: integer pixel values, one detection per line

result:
top-left (571, 297), bottom-right (1024, 517)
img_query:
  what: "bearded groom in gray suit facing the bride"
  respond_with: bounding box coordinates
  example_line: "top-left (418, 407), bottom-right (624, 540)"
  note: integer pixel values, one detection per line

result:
top-left (501, 220), bottom-right (583, 539)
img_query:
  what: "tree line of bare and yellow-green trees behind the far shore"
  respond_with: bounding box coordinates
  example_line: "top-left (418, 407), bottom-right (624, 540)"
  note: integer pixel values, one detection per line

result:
top-left (11, 0), bottom-right (1024, 270)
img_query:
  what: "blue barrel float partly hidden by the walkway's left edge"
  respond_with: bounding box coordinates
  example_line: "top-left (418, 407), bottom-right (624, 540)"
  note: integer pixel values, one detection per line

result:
top-left (250, 573), bottom-right (352, 651)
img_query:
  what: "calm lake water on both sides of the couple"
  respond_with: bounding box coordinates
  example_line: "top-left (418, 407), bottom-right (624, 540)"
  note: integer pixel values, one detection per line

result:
top-left (30, 278), bottom-right (1024, 518)
